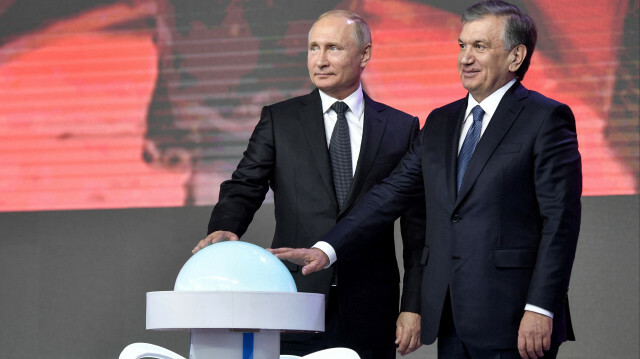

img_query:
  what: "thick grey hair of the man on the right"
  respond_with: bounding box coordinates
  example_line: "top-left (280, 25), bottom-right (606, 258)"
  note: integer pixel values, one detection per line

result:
top-left (462, 0), bottom-right (538, 80)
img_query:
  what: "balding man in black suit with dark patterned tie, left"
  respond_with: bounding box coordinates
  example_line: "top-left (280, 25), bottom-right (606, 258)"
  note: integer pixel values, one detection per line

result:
top-left (194, 10), bottom-right (424, 359)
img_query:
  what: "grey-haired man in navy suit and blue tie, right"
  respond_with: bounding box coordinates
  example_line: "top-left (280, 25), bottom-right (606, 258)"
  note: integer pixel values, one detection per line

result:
top-left (273, 1), bottom-right (582, 359)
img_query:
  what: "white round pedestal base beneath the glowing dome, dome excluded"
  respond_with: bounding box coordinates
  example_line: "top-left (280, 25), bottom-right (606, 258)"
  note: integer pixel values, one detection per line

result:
top-left (147, 291), bottom-right (325, 359)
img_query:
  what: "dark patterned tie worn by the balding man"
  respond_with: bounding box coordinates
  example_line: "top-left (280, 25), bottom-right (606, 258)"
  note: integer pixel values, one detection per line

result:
top-left (329, 101), bottom-right (353, 209)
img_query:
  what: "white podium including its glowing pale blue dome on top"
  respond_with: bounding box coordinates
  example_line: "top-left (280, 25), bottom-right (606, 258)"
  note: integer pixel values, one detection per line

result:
top-left (120, 241), bottom-right (325, 359)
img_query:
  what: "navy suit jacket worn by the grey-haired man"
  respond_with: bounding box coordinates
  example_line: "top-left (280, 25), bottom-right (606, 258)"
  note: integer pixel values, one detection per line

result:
top-left (324, 82), bottom-right (582, 348)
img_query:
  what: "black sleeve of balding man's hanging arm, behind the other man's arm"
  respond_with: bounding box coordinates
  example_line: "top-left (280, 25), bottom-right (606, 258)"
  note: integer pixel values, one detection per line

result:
top-left (400, 118), bottom-right (426, 313)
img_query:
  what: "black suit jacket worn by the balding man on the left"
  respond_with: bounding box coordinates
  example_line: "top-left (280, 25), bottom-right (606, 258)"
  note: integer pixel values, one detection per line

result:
top-left (208, 90), bottom-right (424, 347)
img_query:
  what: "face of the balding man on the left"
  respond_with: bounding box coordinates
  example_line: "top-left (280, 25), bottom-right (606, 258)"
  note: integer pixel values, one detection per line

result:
top-left (307, 16), bottom-right (371, 100)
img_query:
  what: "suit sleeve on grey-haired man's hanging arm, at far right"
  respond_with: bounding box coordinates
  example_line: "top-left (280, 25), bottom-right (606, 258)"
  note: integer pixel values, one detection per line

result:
top-left (527, 105), bottom-right (582, 312)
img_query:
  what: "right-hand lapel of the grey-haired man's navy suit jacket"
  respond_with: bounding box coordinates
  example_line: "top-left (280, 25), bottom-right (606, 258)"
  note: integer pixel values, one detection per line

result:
top-left (457, 82), bottom-right (528, 203)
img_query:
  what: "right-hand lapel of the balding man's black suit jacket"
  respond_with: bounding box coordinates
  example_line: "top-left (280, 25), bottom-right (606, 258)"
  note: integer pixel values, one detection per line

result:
top-left (340, 93), bottom-right (387, 217)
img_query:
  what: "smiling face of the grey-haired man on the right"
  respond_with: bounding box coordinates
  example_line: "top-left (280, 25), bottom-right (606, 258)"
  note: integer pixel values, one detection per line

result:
top-left (458, 16), bottom-right (524, 102)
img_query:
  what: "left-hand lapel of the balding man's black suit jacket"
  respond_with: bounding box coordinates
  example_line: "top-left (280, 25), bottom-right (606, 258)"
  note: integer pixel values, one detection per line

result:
top-left (298, 89), bottom-right (338, 208)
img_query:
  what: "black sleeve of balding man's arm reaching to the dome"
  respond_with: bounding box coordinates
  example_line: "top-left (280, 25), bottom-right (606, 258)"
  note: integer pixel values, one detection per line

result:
top-left (207, 106), bottom-right (275, 236)
